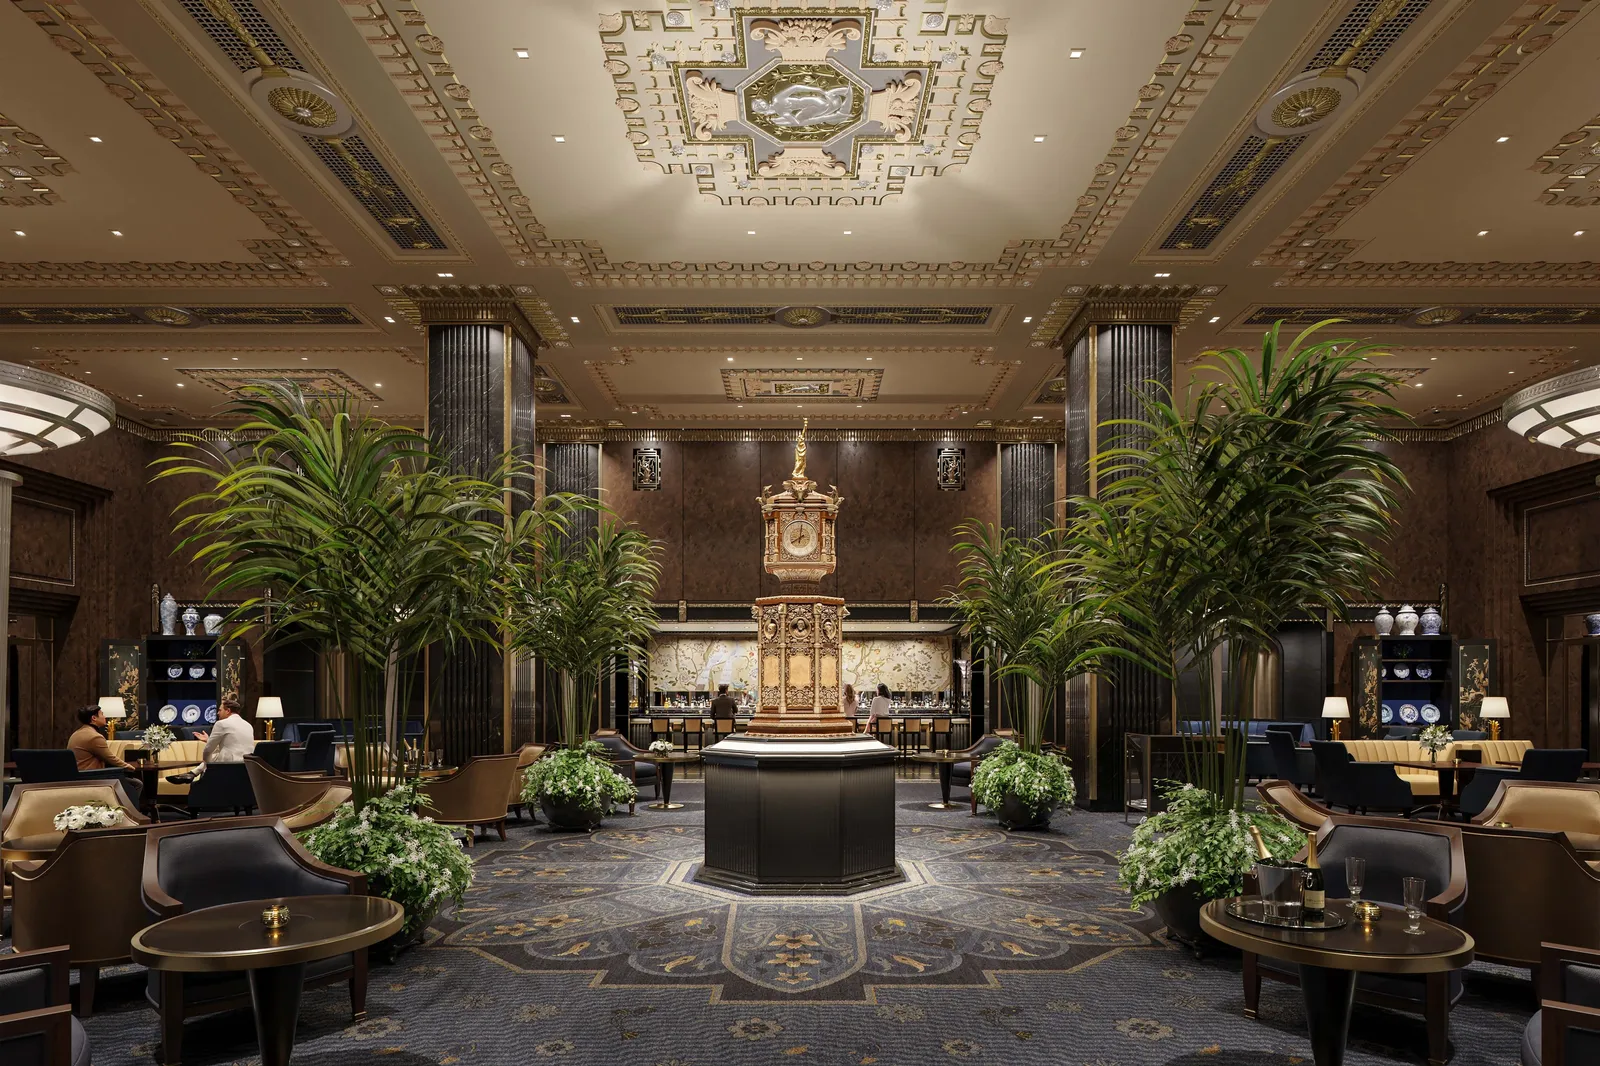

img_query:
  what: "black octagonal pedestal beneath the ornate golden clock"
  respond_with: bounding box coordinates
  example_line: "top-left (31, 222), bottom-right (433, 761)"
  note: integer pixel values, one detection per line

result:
top-left (694, 735), bottom-right (904, 895)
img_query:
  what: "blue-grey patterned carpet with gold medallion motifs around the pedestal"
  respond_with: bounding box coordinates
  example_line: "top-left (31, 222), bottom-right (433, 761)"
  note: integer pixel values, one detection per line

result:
top-left (37, 781), bottom-right (1533, 1066)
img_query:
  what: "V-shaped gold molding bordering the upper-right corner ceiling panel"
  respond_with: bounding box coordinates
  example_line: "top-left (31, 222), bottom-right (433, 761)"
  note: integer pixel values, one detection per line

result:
top-left (1251, 0), bottom-right (1600, 287)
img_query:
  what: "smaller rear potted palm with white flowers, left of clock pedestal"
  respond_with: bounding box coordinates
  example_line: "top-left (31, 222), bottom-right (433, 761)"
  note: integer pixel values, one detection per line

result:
top-left (507, 504), bottom-right (661, 831)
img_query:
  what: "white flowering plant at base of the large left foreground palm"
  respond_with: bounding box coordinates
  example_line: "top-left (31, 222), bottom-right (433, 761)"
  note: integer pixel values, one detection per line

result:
top-left (301, 784), bottom-right (472, 936)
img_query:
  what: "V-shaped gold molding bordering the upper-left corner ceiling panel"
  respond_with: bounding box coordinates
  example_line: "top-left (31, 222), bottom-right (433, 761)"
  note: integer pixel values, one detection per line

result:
top-left (0, 0), bottom-right (337, 287)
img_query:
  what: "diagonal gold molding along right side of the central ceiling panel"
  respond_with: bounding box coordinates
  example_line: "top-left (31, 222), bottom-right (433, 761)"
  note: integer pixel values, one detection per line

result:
top-left (1045, 0), bottom-right (1272, 264)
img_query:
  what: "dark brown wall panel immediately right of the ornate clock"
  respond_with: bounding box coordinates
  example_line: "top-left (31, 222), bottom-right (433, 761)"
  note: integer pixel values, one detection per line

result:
top-left (838, 440), bottom-right (938, 603)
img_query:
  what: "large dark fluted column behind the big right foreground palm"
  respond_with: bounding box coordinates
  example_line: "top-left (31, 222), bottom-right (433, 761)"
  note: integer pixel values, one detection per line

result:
top-left (1061, 298), bottom-right (1182, 810)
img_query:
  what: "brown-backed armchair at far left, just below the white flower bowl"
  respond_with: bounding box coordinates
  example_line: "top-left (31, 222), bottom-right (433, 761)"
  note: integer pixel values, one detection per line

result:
top-left (11, 818), bottom-right (150, 1018)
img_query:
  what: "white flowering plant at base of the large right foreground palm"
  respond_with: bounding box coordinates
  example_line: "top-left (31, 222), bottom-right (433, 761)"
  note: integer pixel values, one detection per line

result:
top-left (1117, 784), bottom-right (1306, 906)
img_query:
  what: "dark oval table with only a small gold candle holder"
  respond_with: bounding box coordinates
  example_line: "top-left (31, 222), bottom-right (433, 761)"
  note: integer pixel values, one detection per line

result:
top-left (130, 896), bottom-right (405, 1066)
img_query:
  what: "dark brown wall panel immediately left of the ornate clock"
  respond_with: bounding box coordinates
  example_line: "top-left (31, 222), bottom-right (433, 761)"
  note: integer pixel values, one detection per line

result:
top-left (680, 442), bottom-right (764, 603)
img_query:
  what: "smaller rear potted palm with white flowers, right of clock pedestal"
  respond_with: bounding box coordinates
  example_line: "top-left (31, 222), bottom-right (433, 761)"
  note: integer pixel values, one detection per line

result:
top-left (947, 522), bottom-right (1120, 829)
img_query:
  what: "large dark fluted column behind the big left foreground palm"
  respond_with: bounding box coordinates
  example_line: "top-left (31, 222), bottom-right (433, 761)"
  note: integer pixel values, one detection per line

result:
top-left (416, 290), bottom-right (539, 765)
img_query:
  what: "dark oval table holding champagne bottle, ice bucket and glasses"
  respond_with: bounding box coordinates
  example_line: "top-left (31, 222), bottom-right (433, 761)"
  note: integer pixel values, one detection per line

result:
top-left (1200, 896), bottom-right (1474, 1066)
